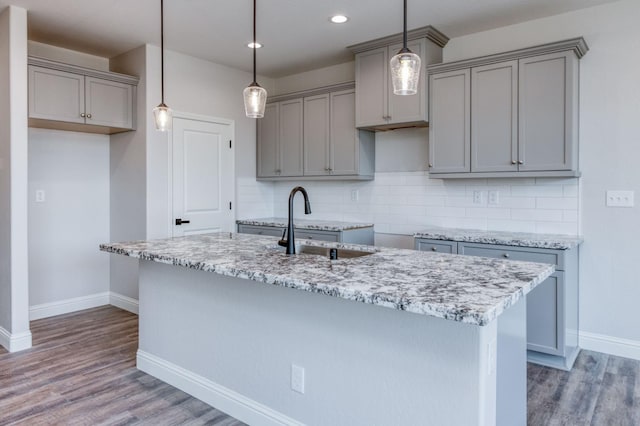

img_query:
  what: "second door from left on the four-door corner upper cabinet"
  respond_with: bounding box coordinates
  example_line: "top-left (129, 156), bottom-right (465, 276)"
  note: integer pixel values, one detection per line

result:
top-left (278, 99), bottom-right (303, 176)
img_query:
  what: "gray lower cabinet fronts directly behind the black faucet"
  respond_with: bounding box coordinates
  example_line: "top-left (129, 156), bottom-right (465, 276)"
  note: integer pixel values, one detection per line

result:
top-left (238, 224), bottom-right (374, 245)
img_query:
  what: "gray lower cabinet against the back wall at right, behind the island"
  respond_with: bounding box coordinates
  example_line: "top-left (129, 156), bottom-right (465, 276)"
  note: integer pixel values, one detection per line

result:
top-left (415, 238), bottom-right (580, 370)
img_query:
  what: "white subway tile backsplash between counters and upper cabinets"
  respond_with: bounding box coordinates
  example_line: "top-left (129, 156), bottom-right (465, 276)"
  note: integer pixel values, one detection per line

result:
top-left (268, 172), bottom-right (580, 235)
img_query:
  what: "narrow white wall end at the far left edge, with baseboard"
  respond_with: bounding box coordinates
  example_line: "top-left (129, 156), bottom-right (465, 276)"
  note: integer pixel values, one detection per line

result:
top-left (0, 6), bottom-right (31, 351)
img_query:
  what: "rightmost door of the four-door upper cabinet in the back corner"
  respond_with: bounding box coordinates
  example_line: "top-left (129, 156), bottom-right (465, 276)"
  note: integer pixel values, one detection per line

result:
top-left (329, 90), bottom-right (360, 175)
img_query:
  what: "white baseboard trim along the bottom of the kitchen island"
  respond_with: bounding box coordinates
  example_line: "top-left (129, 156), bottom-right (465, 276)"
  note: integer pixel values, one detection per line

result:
top-left (136, 350), bottom-right (303, 426)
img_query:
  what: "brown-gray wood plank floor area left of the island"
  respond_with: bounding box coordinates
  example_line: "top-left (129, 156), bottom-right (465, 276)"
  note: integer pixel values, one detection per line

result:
top-left (0, 306), bottom-right (243, 426)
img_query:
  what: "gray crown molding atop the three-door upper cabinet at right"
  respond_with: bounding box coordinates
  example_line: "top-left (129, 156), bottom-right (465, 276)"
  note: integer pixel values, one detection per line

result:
top-left (427, 37), bottom-right (589, 74)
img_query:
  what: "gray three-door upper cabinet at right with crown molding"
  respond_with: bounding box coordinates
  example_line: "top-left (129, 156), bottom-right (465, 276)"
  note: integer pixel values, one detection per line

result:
top-left (429, 38), bottom-right (588, 178)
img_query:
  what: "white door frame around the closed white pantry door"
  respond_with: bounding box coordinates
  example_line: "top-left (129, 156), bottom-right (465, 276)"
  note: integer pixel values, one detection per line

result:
top-left (167, 110), bottom-right (237, 238)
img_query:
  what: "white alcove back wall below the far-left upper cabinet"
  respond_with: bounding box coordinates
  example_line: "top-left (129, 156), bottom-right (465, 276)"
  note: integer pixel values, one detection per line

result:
top-left (29, 129), bottom-right (109, 307)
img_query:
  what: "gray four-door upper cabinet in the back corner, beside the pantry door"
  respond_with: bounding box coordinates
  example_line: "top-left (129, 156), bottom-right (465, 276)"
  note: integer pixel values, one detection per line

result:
top-left (257, 83), bottom-right (375, 180)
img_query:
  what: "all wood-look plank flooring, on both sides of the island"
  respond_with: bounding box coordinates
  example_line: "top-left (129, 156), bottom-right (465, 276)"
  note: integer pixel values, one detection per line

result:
top-left (0, 306), bottom-right (640, 426)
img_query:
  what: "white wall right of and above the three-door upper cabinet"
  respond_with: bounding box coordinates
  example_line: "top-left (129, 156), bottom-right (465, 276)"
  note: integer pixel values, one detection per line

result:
top-left (445, 0), bottom-right (640, 358)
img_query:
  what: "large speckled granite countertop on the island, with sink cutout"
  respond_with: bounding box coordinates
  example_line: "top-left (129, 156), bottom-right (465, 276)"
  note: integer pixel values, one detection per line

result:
top-left (100, 233), bottom-right (554, 326)
